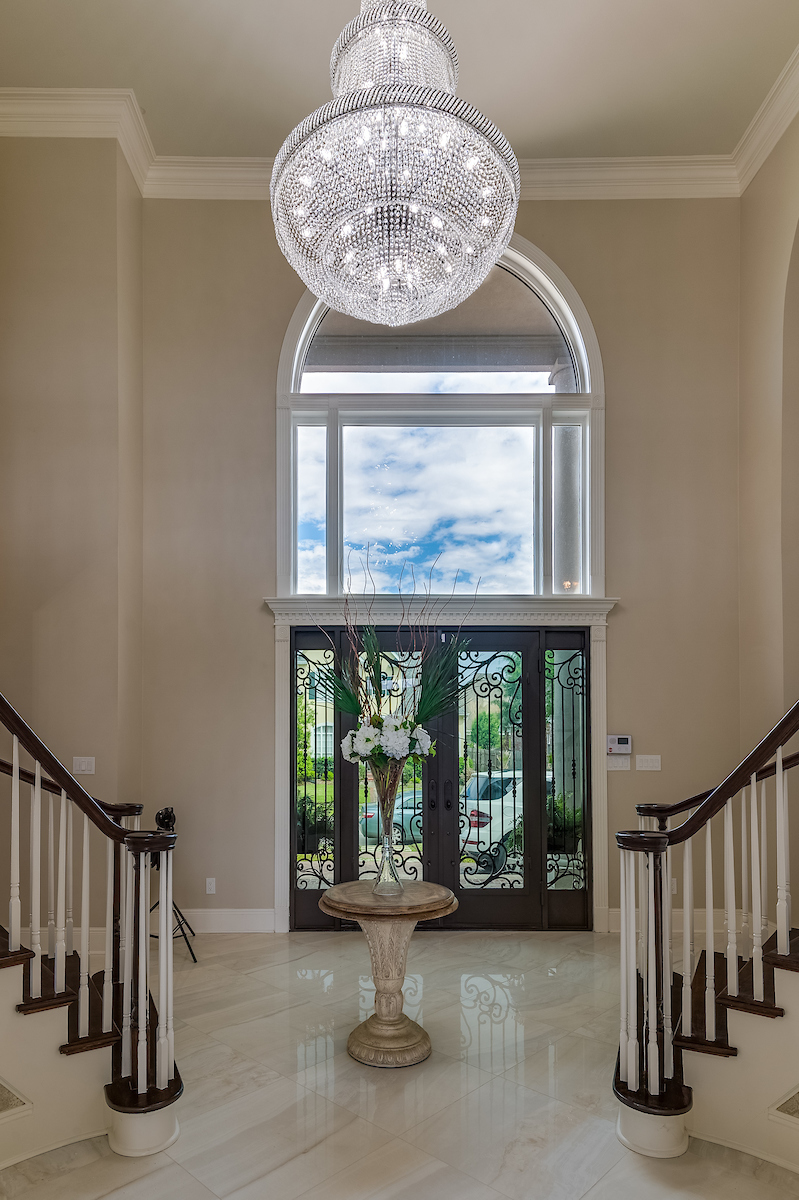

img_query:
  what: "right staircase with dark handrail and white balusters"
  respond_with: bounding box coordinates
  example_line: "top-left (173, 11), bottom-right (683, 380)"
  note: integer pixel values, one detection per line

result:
top-left (613, 703), bottom-right (799, 1171)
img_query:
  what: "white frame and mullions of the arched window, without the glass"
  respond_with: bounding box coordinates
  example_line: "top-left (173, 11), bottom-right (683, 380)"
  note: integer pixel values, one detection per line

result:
top-left (276, 234), bottom-right (605, 600)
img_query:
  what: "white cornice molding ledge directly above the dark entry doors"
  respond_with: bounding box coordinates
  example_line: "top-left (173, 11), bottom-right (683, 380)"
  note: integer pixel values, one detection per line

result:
top-left (264, 595), bottom-right (618, 626)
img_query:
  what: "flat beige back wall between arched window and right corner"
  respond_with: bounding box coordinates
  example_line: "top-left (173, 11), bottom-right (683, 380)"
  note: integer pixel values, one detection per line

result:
top-left (516, 200), bottom-right (739, 907)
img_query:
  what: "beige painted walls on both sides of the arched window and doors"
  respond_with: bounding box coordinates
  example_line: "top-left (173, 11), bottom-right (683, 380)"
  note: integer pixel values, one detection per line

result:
top-left (0, 130), bottom-right (799, 908)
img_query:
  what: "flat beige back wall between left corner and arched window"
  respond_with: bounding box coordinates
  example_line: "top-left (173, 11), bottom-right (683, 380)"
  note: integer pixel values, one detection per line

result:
top-left (144, 200), bottom-right (302, 908)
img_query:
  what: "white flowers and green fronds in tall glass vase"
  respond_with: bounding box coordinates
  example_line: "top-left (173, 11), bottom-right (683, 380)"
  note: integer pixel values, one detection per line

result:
top-left (318, 622), bottom-right (462, 895)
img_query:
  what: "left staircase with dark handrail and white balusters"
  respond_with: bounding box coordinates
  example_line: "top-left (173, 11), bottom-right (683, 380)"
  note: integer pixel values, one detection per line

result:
top-left (0, 696), bottom-right (182, 1169)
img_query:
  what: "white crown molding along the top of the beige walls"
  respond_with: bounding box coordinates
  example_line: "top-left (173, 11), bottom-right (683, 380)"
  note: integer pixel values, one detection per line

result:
top-left (0, 47), bottom-right (799, 200)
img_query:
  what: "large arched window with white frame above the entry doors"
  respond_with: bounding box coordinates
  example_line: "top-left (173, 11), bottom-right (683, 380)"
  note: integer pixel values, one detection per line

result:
top-left (278, 228), bottom-right (605, 596)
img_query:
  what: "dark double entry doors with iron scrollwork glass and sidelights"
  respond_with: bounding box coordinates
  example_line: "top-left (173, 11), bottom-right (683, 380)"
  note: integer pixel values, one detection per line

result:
top-left (292, 628), bottom-right (590, 929)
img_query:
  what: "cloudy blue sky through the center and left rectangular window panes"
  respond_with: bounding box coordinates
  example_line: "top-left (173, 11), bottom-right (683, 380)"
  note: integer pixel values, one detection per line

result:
top-left (298, 417), bottom-right (544, 595)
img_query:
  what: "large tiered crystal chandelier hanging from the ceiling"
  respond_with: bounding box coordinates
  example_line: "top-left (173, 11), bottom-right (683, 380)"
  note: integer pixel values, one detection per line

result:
top-left (271, 0), bottom-right (519, 325)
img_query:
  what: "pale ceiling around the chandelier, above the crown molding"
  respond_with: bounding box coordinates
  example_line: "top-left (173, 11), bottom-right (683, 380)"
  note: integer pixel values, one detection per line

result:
top-left (0, 0), bottom-right (799, 158)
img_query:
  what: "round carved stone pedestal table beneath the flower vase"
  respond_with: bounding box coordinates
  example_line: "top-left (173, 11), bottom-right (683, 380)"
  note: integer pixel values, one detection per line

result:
top-left (319, 880), bottom-right (458, 1067)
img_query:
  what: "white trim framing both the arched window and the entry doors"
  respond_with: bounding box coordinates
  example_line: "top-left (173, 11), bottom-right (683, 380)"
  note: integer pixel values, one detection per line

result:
top-left (265, 234), bottom-right (609, 934)
